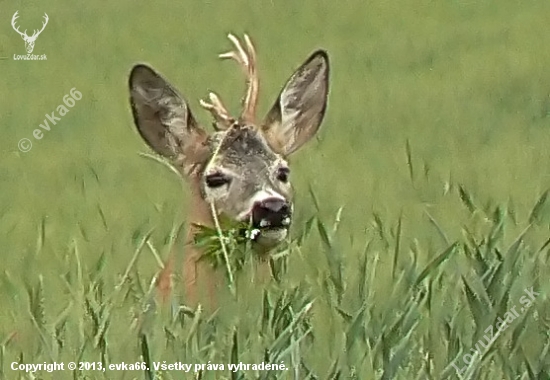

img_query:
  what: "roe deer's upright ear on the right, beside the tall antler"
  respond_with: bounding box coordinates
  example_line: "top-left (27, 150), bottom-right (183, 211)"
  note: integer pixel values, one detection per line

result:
top-left (262, 50), bottom-right (329, 156)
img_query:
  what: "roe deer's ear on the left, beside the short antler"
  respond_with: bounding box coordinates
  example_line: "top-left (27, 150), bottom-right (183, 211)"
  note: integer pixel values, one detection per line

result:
top-left (129, 64), bottom-right (207, 168)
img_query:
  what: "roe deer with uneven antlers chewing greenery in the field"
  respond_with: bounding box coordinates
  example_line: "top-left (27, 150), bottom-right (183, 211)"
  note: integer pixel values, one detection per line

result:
top-left (129, 35), bottom-right (329, 305)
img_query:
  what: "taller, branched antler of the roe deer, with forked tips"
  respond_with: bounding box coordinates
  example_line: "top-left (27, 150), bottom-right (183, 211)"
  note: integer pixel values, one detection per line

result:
top-left (220, 34), bottom-right (259, 123)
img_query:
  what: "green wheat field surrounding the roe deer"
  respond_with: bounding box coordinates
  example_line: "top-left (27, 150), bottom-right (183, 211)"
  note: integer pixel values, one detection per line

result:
top-left (0, 0), bottom-right (550, 380)
